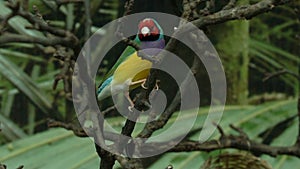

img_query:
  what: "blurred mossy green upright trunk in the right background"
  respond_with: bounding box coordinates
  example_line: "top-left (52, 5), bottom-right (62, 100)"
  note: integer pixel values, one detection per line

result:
top-left (211, 0), bottom-right (249, 104)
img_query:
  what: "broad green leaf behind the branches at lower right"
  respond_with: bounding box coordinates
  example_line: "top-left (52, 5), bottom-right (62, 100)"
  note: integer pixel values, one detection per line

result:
top-left (150, 100), bottom-right (297, 169)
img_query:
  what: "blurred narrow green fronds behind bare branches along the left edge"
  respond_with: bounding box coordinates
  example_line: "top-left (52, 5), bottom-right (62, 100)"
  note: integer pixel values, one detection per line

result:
top-left (0, 1), bottom-right (64, 141)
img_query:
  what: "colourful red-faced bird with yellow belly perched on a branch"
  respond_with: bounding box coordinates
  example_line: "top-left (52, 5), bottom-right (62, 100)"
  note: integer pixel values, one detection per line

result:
top-left (97, 18), bottom-right (165, 108)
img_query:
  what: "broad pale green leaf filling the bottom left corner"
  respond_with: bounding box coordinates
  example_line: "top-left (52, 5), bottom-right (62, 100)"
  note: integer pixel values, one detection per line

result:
top-left (0, 129), bottom-right (99, 169)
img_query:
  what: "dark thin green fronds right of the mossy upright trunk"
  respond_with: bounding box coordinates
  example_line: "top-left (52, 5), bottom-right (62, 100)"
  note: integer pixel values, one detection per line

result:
top-left (249, 2), bottom-right (300, 95)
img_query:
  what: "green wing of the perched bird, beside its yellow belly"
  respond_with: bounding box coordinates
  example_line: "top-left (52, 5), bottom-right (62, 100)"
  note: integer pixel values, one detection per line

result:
top-left (103, 37), bottom-right (141, 81)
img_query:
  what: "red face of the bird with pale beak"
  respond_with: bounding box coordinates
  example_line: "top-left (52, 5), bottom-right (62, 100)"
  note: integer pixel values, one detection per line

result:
top-left (138, 18), bottom-right (160, 41)
